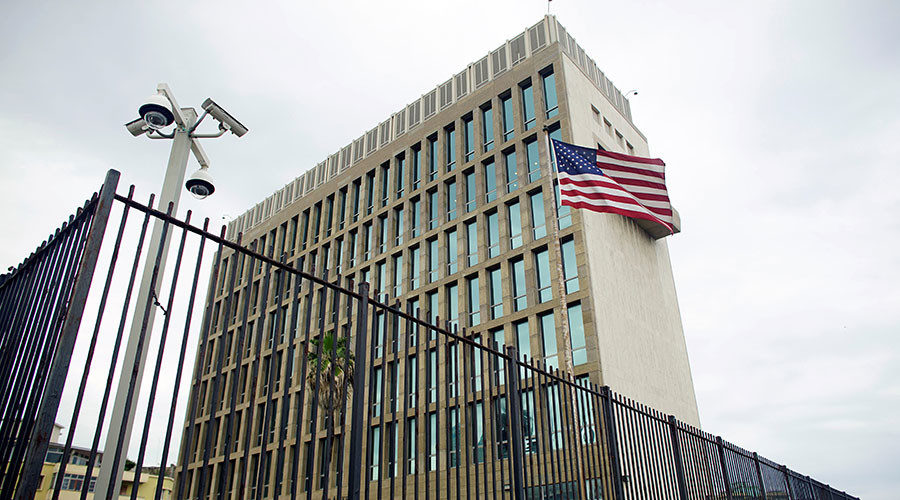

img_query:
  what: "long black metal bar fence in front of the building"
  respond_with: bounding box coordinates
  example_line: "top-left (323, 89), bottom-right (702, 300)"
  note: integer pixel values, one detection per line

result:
top-left (0, 170), bottom-right (854, 500)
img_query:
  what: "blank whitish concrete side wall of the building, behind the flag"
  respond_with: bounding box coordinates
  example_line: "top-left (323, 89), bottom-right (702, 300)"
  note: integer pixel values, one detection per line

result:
top-left (560, 55), bottom-right (700, 426)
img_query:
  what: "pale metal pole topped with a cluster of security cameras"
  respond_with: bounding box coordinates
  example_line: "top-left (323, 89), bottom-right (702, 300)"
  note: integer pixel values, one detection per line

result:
top-left (94, 83), bottom-right (247, 498)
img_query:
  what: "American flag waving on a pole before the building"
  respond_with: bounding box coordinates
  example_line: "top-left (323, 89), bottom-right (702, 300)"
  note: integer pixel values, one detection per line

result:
top-left (553, 139), bottom-right (675, 234)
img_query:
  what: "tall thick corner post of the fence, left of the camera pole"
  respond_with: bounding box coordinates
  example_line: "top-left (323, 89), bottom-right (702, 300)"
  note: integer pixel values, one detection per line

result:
top-left (16, 170), bottom-right (119, 500)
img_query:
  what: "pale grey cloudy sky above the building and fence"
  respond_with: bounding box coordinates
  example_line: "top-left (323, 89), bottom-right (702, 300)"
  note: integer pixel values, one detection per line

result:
top-left (0, 0), bottom-right (900, 499)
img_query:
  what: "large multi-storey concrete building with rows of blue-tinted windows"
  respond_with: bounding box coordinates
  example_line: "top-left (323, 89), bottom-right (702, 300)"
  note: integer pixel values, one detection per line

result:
top-left (179, 16), bottom-right (699, 498)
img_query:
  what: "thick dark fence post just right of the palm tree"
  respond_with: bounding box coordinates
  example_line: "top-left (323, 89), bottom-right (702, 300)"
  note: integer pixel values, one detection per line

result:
top-left (347, 281), bottom-right (369, 500)
